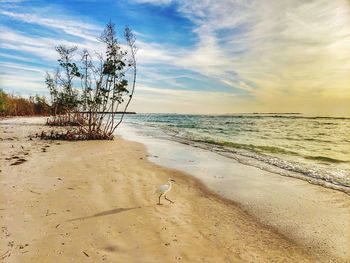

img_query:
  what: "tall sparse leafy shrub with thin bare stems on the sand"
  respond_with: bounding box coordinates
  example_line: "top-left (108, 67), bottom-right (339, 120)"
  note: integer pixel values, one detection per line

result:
top-left (43, 22), bottom-right (137, 140)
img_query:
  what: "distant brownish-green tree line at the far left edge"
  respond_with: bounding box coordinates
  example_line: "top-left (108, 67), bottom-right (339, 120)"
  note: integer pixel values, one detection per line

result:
top-left (0, 89), bottom-right (52, 116)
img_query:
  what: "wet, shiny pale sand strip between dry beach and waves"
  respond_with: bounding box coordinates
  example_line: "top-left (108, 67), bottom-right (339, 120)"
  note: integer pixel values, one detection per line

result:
top-left (119, 122), bottom-right (350, 260)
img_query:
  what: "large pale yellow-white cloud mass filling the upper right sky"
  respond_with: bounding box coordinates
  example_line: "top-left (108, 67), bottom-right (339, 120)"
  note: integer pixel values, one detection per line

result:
top-left (142, 0), bottom-right (350, 114)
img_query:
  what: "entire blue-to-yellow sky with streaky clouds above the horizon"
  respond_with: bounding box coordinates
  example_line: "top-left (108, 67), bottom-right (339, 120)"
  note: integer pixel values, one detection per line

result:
top-left (0, 0), bottom-right (350, 116)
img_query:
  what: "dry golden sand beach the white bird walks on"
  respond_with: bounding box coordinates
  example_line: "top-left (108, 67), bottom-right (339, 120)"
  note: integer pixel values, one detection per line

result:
top-left (0, 119), bottom-right (350, 262)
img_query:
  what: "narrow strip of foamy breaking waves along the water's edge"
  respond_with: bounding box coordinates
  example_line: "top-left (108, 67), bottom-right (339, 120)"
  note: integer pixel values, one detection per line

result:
top-left (120, 123), bottom-right (350, 194)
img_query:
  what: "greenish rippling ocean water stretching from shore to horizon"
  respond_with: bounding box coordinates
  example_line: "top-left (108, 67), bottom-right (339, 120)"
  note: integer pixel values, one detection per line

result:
top-left (121, 114), bottom-right (350, 193)
